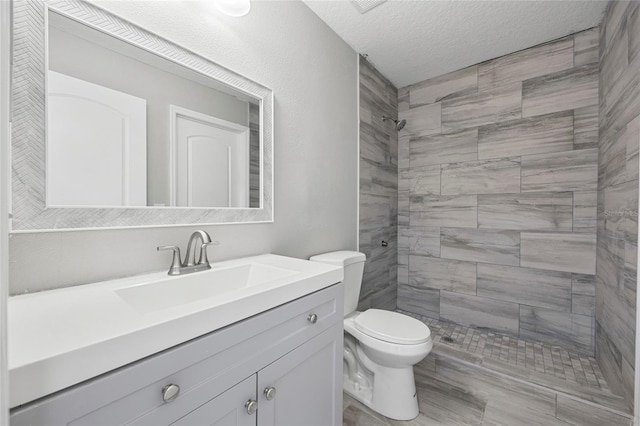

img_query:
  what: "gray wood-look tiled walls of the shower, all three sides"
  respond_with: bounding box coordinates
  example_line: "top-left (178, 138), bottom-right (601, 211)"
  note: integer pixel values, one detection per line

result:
top-left (360, 2), bottom-right (640, 420)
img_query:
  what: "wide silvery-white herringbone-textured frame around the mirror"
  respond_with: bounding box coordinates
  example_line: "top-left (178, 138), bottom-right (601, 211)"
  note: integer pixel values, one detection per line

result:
top-left (11, 0), bottom-right (273, 233)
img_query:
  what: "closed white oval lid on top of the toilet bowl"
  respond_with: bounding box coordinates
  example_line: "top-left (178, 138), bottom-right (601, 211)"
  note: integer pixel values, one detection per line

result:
top-left (354, 309), bottom-right (431, 345)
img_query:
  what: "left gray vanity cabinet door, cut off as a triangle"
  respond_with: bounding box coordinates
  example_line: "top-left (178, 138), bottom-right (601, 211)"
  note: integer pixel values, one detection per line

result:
top-left (172, 374), bottom-right (256, 426)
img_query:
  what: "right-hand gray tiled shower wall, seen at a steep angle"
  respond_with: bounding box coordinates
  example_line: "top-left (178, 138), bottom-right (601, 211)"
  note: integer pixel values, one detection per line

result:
top-left (595, 1), bottom-right (640, 410)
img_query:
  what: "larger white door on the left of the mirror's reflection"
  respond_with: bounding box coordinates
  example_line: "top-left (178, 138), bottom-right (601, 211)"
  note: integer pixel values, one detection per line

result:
top-left (46, 71), bottom-right (147, 206)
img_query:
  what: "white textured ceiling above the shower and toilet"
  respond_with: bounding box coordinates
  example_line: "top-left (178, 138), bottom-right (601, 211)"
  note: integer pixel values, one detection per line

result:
top-left (303, 0), bottom-right (607, 88)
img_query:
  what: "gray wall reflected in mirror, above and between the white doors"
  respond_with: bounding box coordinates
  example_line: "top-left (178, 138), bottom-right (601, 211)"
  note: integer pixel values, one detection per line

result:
top-left (49, 26), bottom-right (249, 206)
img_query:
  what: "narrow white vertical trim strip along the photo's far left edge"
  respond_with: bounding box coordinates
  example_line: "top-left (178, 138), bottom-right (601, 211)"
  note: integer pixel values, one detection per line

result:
top-left (0, 1), bottom-right (12, 425)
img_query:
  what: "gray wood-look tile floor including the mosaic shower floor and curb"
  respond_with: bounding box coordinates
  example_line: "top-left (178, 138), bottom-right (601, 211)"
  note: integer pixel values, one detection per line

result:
top-left (343, 312), bottom-right (631, 426)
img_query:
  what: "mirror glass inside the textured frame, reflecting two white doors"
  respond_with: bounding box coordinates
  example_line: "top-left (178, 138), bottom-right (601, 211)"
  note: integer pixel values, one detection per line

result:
top-left (47, 9), bottom-right (260, 208)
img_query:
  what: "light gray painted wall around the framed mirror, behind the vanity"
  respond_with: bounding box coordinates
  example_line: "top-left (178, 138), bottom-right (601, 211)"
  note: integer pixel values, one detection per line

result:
top-left (10, 1), bottom-right (358, 293)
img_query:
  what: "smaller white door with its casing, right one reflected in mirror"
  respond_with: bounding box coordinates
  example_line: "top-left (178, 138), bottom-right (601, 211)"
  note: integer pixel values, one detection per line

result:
top-left (170, 105), bottom-right (249, 207)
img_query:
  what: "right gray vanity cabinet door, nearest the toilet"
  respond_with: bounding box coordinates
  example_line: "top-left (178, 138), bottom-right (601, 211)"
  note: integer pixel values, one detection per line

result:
top-left (258, 324), bottom-right (342, 426)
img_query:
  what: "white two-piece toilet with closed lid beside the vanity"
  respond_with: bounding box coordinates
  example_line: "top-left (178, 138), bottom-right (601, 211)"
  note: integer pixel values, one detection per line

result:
top-left (309, 251), bottom-right (433, 420)
